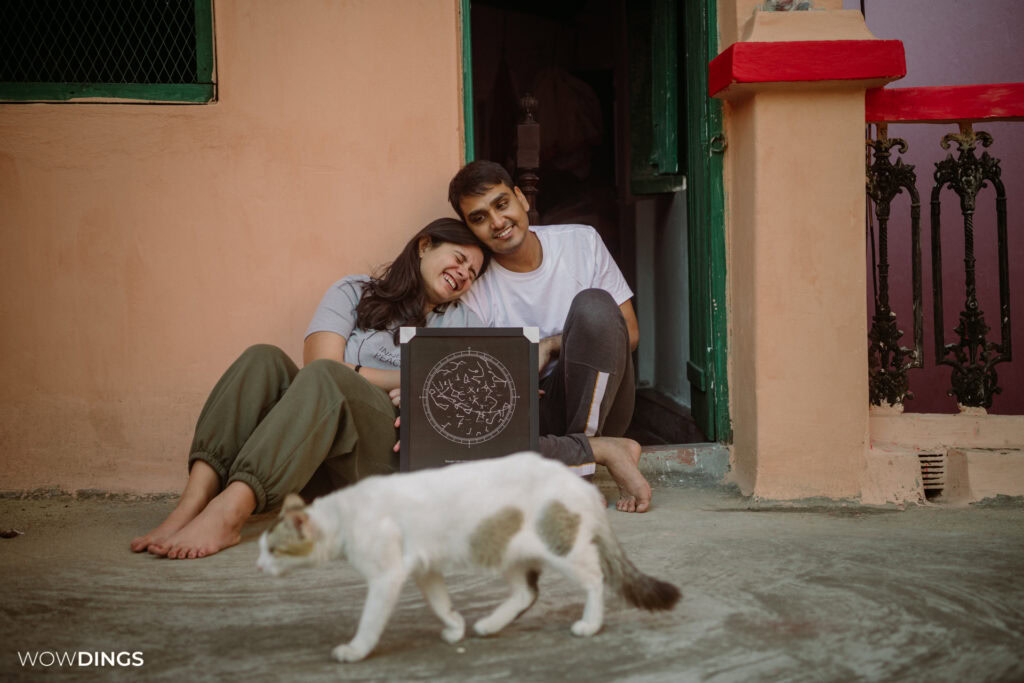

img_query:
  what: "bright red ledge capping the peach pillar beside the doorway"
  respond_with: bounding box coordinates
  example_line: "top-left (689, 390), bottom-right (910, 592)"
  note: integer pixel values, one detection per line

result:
top-left (708, 40), bottom-right (906, 97)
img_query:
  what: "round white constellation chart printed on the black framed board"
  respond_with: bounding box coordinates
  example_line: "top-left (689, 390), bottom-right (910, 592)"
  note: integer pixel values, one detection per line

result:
top-left (420, 349), bottom-right (519, 445)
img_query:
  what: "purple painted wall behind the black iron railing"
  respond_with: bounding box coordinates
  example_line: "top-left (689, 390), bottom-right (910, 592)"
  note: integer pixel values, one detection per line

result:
top-left (844, 0), bottom-right (1024, 415)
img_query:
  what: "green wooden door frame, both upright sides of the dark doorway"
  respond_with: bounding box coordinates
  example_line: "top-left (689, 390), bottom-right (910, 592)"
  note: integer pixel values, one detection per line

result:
top-left (459, 0), bottom-right (732, 441)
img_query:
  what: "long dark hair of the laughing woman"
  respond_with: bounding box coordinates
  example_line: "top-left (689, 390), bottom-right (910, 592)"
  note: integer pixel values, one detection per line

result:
top-left (355, 218), bottom-right (490, 344)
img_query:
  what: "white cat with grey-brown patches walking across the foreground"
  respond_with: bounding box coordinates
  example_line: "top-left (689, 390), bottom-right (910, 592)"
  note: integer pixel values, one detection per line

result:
top-left (257, 453), bottom-right (680, 661)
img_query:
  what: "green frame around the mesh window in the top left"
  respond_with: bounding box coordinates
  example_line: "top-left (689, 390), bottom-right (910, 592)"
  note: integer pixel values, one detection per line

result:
top-left (0, 0), bottom-right (217, 103)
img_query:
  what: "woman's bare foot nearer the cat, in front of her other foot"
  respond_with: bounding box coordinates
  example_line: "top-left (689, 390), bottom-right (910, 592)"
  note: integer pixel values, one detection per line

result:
top-left (150, 481), bottom-right (256, 560)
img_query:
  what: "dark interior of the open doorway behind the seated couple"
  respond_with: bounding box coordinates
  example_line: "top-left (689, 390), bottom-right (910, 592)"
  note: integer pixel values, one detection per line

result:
top-left (471, 0), bottom-right (706, 444)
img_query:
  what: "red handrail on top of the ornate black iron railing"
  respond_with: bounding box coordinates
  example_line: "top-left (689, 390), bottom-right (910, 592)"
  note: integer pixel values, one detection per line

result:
top-left (864, 83), bottom-right (1024, 123)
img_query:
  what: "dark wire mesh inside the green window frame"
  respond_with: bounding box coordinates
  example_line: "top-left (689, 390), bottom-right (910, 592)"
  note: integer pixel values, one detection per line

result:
top-left (0, 0), bottom-right (200, 84)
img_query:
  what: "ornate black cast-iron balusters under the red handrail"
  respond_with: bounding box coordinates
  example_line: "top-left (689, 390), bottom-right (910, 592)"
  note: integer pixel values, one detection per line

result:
top-left (866, 84), bottom-right (1024, 409)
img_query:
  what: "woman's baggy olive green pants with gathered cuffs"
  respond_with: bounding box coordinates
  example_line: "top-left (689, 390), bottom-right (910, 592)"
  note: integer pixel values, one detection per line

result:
top-left (188, 344), bottom-right (398, 512)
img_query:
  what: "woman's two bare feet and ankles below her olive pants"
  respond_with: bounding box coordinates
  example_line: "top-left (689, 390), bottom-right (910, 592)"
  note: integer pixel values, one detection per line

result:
top-left (131, 460), bottom-right (256, 559)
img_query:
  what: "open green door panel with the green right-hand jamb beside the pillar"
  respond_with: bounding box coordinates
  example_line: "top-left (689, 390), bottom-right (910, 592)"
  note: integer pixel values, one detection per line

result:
top-left (629, 0), bottom-right (731, 441)
